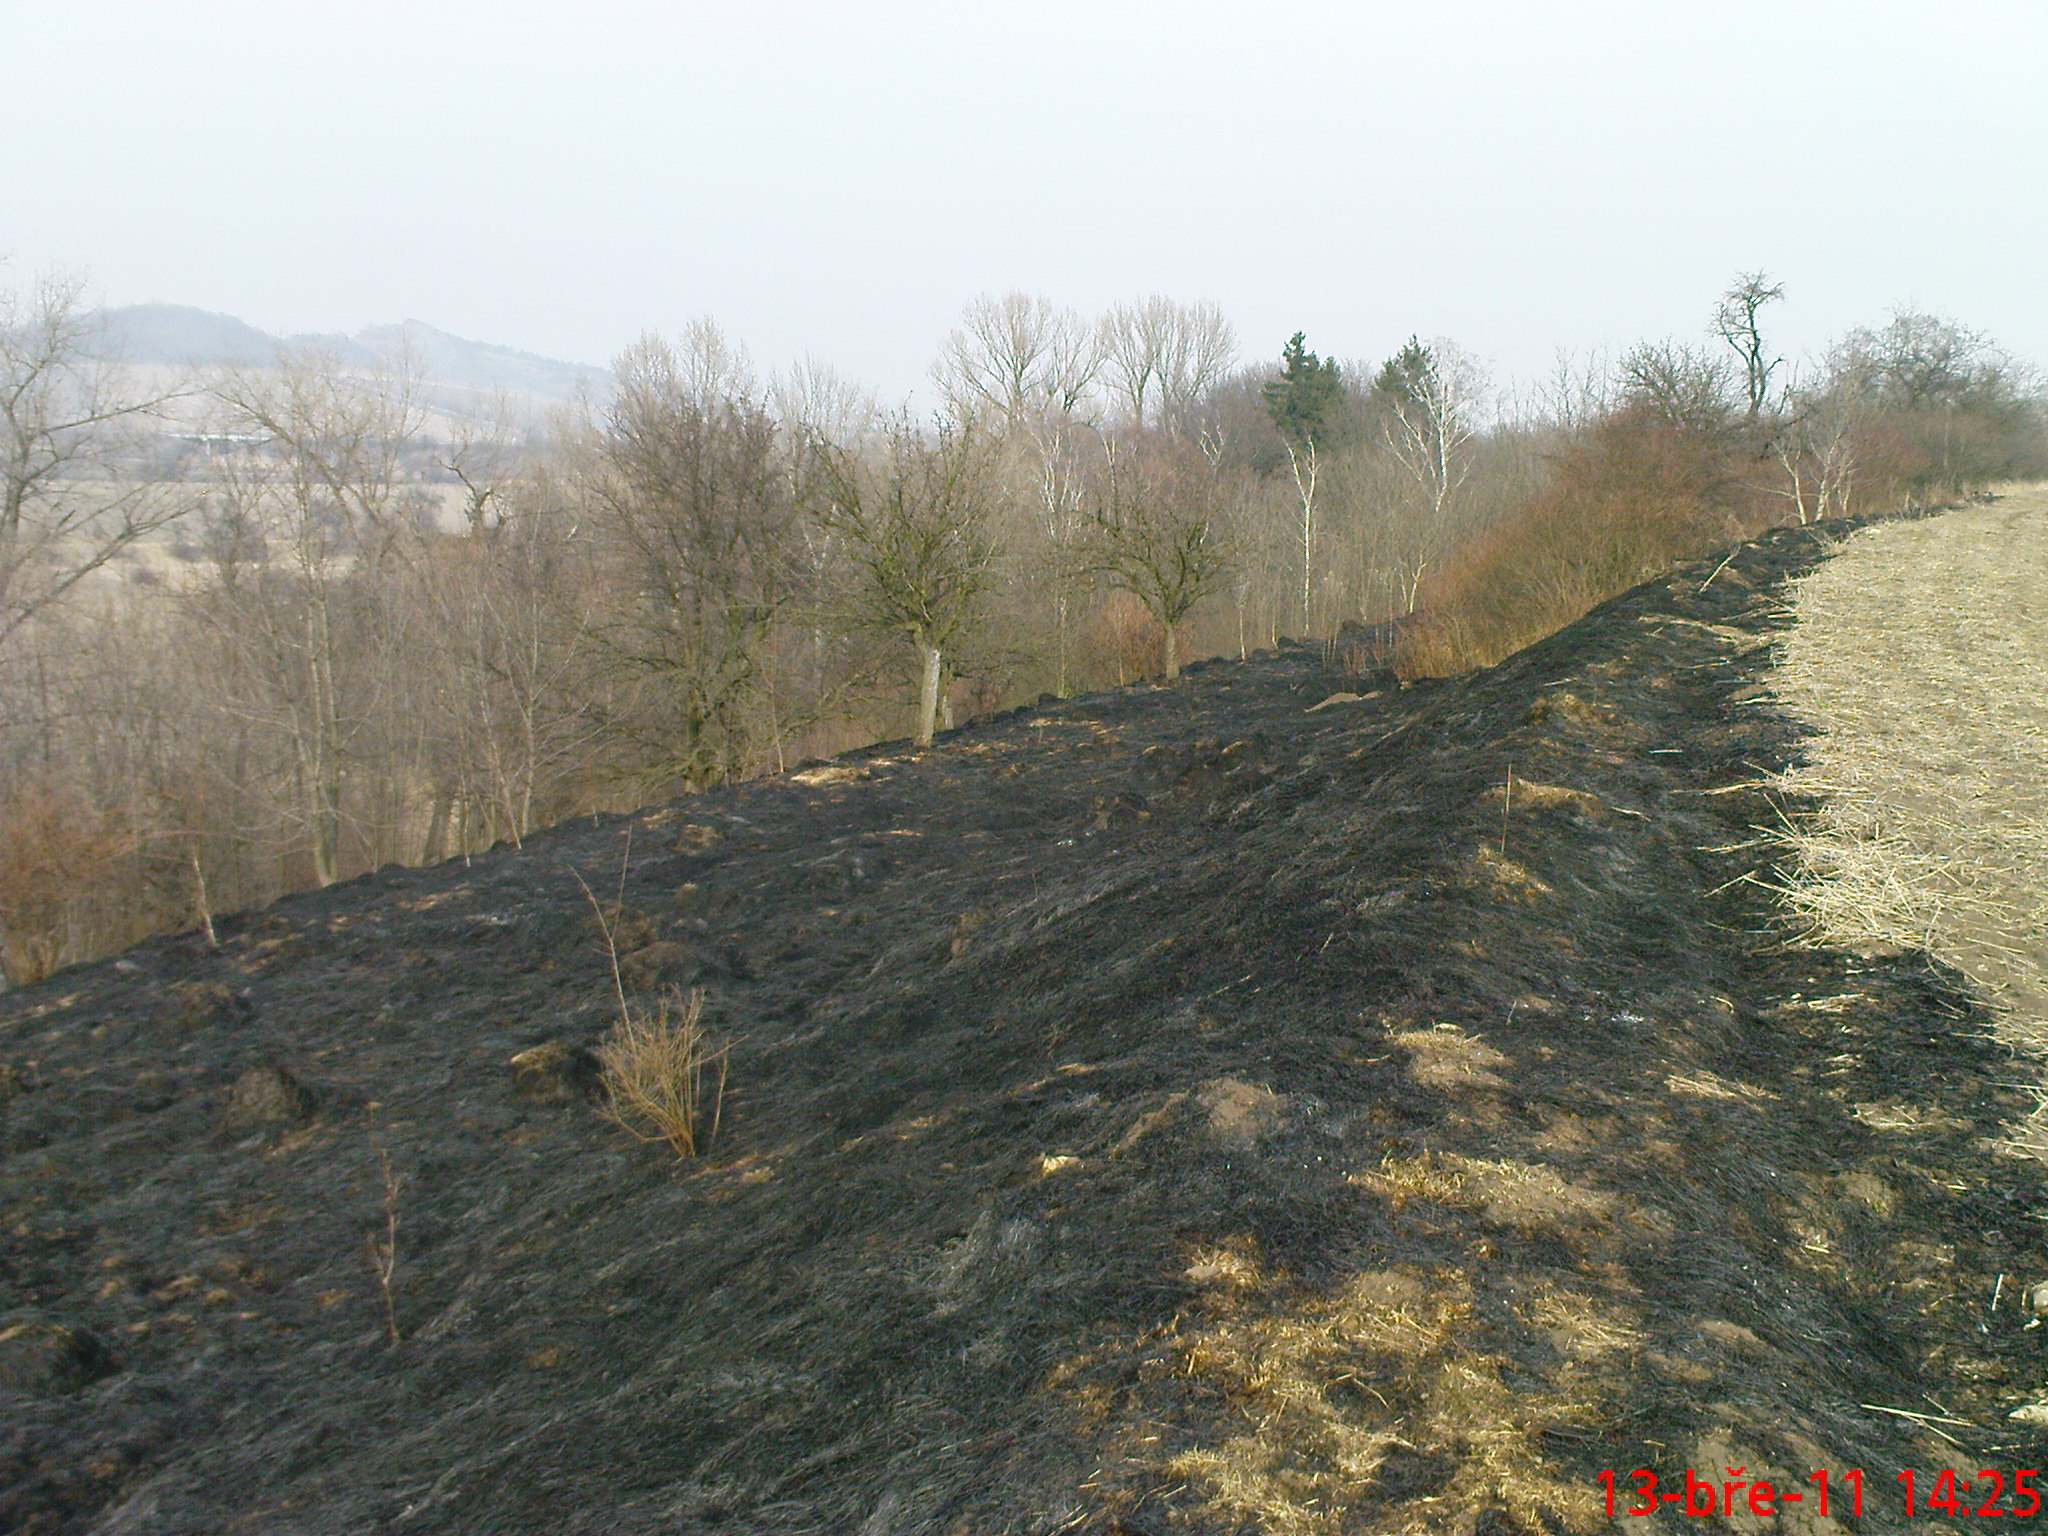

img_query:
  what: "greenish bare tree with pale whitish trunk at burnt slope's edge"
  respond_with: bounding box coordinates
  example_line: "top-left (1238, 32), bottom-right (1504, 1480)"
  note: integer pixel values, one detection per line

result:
top-left (817, 420), bottom-right (995, 745)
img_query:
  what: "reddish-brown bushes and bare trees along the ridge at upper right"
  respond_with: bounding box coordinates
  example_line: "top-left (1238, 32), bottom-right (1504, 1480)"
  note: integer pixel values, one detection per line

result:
top-left (1403, 286), bottom-right (2048, 674)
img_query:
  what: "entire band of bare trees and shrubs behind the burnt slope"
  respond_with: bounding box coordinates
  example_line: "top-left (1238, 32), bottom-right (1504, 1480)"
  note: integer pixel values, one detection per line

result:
top-left (0, 276), bottom-right (2048, 983)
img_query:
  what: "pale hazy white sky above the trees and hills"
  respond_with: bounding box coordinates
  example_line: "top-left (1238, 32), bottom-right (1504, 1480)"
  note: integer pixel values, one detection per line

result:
top-left (0, 0), bottom-right (2048, 393)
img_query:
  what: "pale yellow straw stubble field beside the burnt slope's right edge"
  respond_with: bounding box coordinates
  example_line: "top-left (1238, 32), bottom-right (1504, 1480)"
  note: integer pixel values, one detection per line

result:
top-left (1772, 485), bottom-right (2048, 1145)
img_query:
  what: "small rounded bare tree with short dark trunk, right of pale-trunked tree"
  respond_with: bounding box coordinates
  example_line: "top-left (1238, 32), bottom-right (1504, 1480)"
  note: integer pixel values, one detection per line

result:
top-left (1094, 432), bottom-right (1229, 682)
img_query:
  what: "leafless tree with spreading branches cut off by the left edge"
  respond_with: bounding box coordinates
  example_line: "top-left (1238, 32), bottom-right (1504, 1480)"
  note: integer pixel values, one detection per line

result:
top-left (0, 276), bottom-right (193, 643)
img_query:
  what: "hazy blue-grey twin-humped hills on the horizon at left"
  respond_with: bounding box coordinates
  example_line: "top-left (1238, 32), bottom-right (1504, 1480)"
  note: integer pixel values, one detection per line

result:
top-left (104, 303), bottom-right (610, 401)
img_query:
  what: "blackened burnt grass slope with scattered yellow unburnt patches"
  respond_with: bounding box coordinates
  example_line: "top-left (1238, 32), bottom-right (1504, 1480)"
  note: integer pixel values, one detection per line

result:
top-left (0, 530), bottom-right (2048, 1536)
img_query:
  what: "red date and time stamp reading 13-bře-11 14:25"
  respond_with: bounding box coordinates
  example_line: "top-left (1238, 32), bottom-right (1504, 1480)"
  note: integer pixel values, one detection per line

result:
top-left (1599, 1466), bottom-right (2048, 1520)
